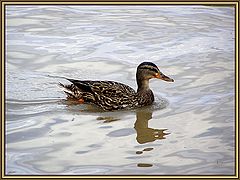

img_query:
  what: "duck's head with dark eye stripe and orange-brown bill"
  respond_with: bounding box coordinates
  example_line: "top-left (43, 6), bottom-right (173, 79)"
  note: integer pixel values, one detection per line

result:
top-left (137, 62), bottom-right (174, 82)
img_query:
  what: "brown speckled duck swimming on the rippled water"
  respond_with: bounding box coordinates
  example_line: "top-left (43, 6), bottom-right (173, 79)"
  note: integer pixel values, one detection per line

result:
top-left (59, 62), bottom-right (174, 111)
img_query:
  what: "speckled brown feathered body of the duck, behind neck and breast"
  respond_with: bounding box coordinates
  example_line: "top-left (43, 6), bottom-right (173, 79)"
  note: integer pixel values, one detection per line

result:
top-left (60, 79), bottom-right (138, 111)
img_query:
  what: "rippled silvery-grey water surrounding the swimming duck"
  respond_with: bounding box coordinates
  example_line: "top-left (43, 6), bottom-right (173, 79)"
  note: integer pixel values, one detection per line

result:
top-left (6, 5), bottom-right (235, 175)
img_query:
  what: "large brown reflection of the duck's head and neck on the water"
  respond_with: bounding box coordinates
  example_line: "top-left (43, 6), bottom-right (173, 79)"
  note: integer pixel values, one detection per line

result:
top-left (134, 109), bottom-right (170, 144)
